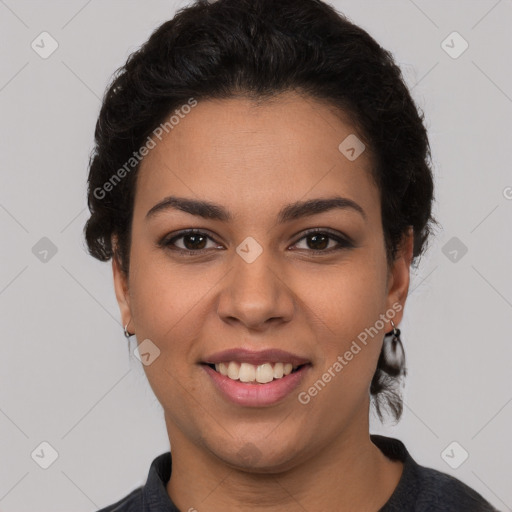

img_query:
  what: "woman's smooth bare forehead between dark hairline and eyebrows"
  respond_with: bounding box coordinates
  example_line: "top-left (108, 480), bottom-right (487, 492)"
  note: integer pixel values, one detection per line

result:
top-left (136, 93), bottom-right (379, 224)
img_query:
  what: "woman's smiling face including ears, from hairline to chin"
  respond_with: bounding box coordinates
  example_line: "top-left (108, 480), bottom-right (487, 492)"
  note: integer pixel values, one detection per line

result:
top-left (114, 93), bottom-right (412, 471)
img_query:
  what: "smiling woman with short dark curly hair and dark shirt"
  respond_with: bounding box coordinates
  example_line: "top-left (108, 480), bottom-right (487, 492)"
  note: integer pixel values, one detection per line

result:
top-left (85, 0), bottom-right (500, 512)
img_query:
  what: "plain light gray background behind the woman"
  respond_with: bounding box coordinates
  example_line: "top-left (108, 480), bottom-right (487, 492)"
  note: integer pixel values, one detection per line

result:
top-left (0, 0), bottom-right (512, 512)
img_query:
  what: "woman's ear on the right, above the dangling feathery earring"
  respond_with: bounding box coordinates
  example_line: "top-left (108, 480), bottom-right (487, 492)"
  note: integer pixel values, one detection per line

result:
top-left (386, 226), bottom-right (414, 325)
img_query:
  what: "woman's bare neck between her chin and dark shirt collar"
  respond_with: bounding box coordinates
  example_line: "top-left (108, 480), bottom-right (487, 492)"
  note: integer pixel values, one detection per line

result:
top-left (167, 417), bottom-right (403, 512)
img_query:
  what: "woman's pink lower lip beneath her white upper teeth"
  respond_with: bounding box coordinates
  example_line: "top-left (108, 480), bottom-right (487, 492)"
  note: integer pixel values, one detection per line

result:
top-left (202, 364), bottom-right (310, 407)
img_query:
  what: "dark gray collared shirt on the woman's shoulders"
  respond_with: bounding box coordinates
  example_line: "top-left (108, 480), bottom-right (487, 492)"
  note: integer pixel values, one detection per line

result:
top-left (99, 434), bottom-right (499, 512)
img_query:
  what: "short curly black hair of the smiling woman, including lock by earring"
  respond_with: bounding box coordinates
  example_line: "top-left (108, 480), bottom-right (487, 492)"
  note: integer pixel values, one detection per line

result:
top-left (84, 0), bottom-right (437, 420)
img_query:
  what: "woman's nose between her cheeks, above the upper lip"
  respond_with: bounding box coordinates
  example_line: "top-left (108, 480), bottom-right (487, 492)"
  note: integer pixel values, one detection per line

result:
top-left (218, 244), bottom-right (296, 331)
